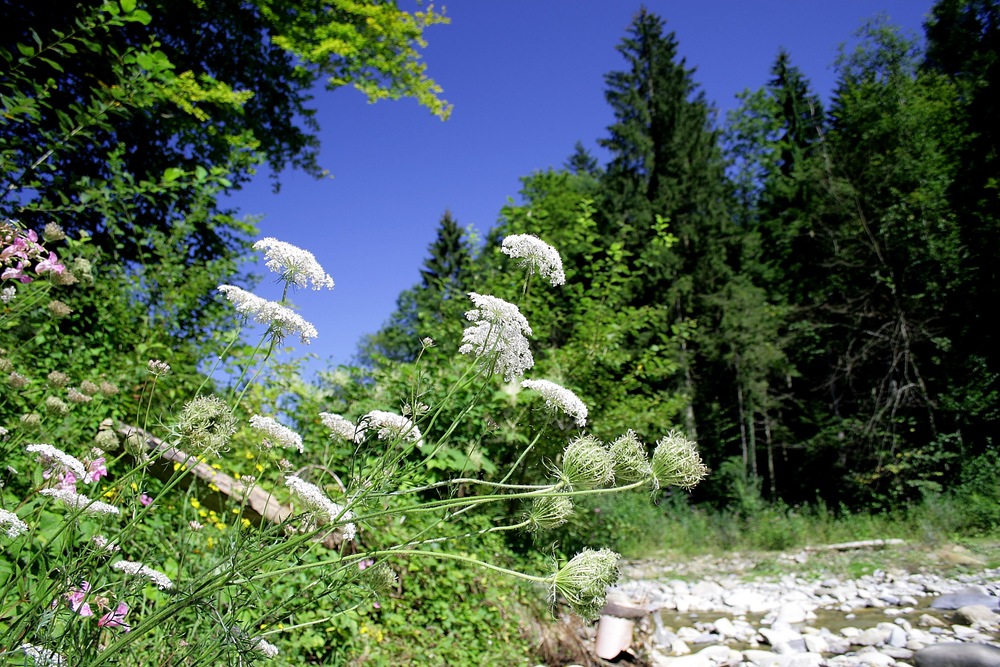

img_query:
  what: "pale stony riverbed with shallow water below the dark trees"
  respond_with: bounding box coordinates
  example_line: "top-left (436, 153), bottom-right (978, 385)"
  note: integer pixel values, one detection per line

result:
top-left (556, 545), bottom-right (1000, 667)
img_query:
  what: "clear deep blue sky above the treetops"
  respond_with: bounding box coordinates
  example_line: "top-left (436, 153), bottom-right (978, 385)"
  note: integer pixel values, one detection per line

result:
top-left (230, 0), bottom-right (932, 370)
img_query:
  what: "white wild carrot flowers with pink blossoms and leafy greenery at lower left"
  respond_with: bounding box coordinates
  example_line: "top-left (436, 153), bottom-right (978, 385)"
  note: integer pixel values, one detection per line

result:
top-left (0, 221), bottom-right (707, 665)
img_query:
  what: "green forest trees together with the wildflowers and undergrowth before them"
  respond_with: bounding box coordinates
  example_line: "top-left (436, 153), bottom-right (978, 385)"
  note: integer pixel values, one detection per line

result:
top-left (0, 0), bottom-right (1000, 665)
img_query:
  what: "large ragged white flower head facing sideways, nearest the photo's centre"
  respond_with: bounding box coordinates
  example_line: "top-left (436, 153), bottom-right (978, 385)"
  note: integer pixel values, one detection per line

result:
top-left (458, 292), bottom-right (535, 382)
